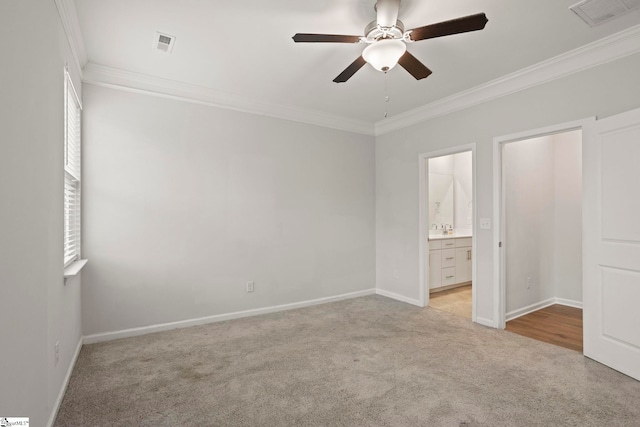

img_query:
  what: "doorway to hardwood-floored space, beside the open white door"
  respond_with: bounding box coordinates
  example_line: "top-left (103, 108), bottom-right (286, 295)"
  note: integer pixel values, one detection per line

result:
top-left (494, 122), bottom-right (583, 351)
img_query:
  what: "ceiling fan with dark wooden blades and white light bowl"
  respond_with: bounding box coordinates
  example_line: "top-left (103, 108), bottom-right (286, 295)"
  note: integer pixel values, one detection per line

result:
top-left (293, 0), bottom-right (488, 83)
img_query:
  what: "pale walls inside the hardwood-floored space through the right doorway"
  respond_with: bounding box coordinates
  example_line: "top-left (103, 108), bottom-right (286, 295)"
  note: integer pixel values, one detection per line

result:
top-left (502, 130), bottom-right (582, 313)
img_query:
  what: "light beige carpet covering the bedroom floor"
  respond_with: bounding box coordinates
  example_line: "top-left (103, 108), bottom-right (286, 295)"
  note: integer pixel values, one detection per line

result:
top-left (55, 296), bottom-right (640, 427)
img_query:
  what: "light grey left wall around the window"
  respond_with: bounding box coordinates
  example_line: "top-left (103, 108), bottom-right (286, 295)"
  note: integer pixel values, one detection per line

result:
top-left (0, 0), bottom-right (81, 426)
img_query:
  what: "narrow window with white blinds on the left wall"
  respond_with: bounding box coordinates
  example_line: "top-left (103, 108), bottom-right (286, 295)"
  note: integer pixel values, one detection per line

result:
top-left (64, 70), bottom-right (82, 267)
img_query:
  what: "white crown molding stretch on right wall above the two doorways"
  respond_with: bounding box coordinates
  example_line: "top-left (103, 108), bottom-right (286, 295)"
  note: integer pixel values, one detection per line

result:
top-left (375, 25), bottom-right (640, 136)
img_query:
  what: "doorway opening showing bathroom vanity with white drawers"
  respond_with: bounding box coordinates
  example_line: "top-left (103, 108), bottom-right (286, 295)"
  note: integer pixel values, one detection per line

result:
top-left (420, 144), bottom-right (476, 321)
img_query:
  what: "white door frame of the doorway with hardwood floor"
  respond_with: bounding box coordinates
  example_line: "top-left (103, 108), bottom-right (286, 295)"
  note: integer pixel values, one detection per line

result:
top-left (493, 117), bottom-right (596, 329)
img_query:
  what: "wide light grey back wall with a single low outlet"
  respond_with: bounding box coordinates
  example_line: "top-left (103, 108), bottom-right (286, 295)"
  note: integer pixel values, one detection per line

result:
top-left (83, 85), bottom-right (375, 335)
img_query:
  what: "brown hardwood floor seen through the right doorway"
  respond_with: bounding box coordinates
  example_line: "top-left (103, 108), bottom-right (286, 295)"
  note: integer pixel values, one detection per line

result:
top-left (506, 304), bottom-right (582, 353)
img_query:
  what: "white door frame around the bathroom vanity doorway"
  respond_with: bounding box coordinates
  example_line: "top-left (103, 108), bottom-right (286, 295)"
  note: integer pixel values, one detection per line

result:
top-left (418, 142), bottom-right (478, 322)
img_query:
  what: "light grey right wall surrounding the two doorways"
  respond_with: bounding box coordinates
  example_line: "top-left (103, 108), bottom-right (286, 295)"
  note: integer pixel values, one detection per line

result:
top-left (376, 54), bottom-right (640, 322)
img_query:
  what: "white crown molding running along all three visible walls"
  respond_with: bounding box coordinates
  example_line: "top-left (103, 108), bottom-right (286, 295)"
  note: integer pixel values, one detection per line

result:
top-left (76, 20), bottom-right (640, 136)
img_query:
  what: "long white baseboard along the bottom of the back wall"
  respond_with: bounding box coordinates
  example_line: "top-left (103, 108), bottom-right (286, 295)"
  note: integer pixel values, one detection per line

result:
top-left (84, 289), bottom-right (376, 344)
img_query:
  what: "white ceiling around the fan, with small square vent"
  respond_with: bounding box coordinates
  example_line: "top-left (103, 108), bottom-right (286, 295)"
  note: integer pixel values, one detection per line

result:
top-left (75, 0), bottom-right (640, 123)
